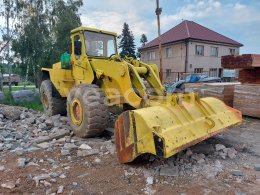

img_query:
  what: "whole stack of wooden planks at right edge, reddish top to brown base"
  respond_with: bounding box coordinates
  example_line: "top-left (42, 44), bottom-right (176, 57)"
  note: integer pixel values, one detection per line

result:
top-left (221, 54), bottom-right (260, 118)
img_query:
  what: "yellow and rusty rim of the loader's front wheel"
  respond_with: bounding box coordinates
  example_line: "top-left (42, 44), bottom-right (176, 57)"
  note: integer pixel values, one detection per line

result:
top-left (70, 99), bottom-right (83, 126)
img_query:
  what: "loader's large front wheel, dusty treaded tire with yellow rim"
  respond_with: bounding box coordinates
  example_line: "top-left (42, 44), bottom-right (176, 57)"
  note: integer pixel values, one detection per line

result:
top-left (67, 84), bottom-right (109, 137)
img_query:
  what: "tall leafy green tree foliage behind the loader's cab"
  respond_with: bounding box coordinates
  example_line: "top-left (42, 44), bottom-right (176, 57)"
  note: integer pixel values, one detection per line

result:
top-left (12, 0), bottom-right (83, 82)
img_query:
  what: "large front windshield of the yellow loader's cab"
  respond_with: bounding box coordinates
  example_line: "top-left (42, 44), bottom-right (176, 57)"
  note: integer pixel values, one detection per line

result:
top-left (84, 31), bottom-right (117, 57)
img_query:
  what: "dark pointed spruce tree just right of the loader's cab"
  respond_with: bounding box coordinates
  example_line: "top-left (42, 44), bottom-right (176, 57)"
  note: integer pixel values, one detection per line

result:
top-left (119, 23), bottom-right (136, 58)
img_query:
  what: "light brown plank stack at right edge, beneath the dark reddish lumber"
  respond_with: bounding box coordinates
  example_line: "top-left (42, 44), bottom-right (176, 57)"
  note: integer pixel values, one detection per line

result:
top-left (234, 84), bottom-right (260, 118)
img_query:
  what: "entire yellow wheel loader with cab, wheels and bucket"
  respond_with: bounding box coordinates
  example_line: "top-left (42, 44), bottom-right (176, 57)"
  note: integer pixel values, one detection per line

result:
top-left (40, 27), bottom-right (242, 163)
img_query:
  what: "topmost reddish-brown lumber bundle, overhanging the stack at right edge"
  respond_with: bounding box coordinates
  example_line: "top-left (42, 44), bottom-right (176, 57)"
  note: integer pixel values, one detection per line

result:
top-left (221, 54), bottom-right (260, 69)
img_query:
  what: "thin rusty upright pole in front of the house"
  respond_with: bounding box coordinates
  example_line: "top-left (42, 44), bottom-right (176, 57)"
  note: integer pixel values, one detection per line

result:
top-left (155, 0), bottom-right (163, 82)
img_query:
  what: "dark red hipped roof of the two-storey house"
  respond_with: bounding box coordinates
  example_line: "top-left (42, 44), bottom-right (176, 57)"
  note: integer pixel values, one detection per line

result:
top-left (140, 20), bottom-right (243, 50)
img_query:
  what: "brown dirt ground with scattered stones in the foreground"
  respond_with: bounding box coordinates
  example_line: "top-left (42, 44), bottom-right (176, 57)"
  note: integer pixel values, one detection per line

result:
top-left (0, 114), bottom-right (260, 195)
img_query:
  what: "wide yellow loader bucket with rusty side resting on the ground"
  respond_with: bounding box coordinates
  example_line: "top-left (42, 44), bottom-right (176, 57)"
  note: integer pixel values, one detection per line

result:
top-left (115, 94), bottom-right (242, 163)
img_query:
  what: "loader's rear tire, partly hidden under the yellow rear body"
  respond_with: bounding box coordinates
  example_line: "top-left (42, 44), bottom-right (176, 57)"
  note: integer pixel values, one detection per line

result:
top-left (40, 80), bottom-right (66, 116)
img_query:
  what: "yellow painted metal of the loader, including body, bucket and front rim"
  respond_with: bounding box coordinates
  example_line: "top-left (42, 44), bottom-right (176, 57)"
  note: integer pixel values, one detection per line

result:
top-left (42, 27), bottom-right (242, 163)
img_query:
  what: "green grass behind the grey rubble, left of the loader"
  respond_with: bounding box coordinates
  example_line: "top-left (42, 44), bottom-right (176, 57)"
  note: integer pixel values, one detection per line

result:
top-left (0, 85), bottom-right (43, 111)
